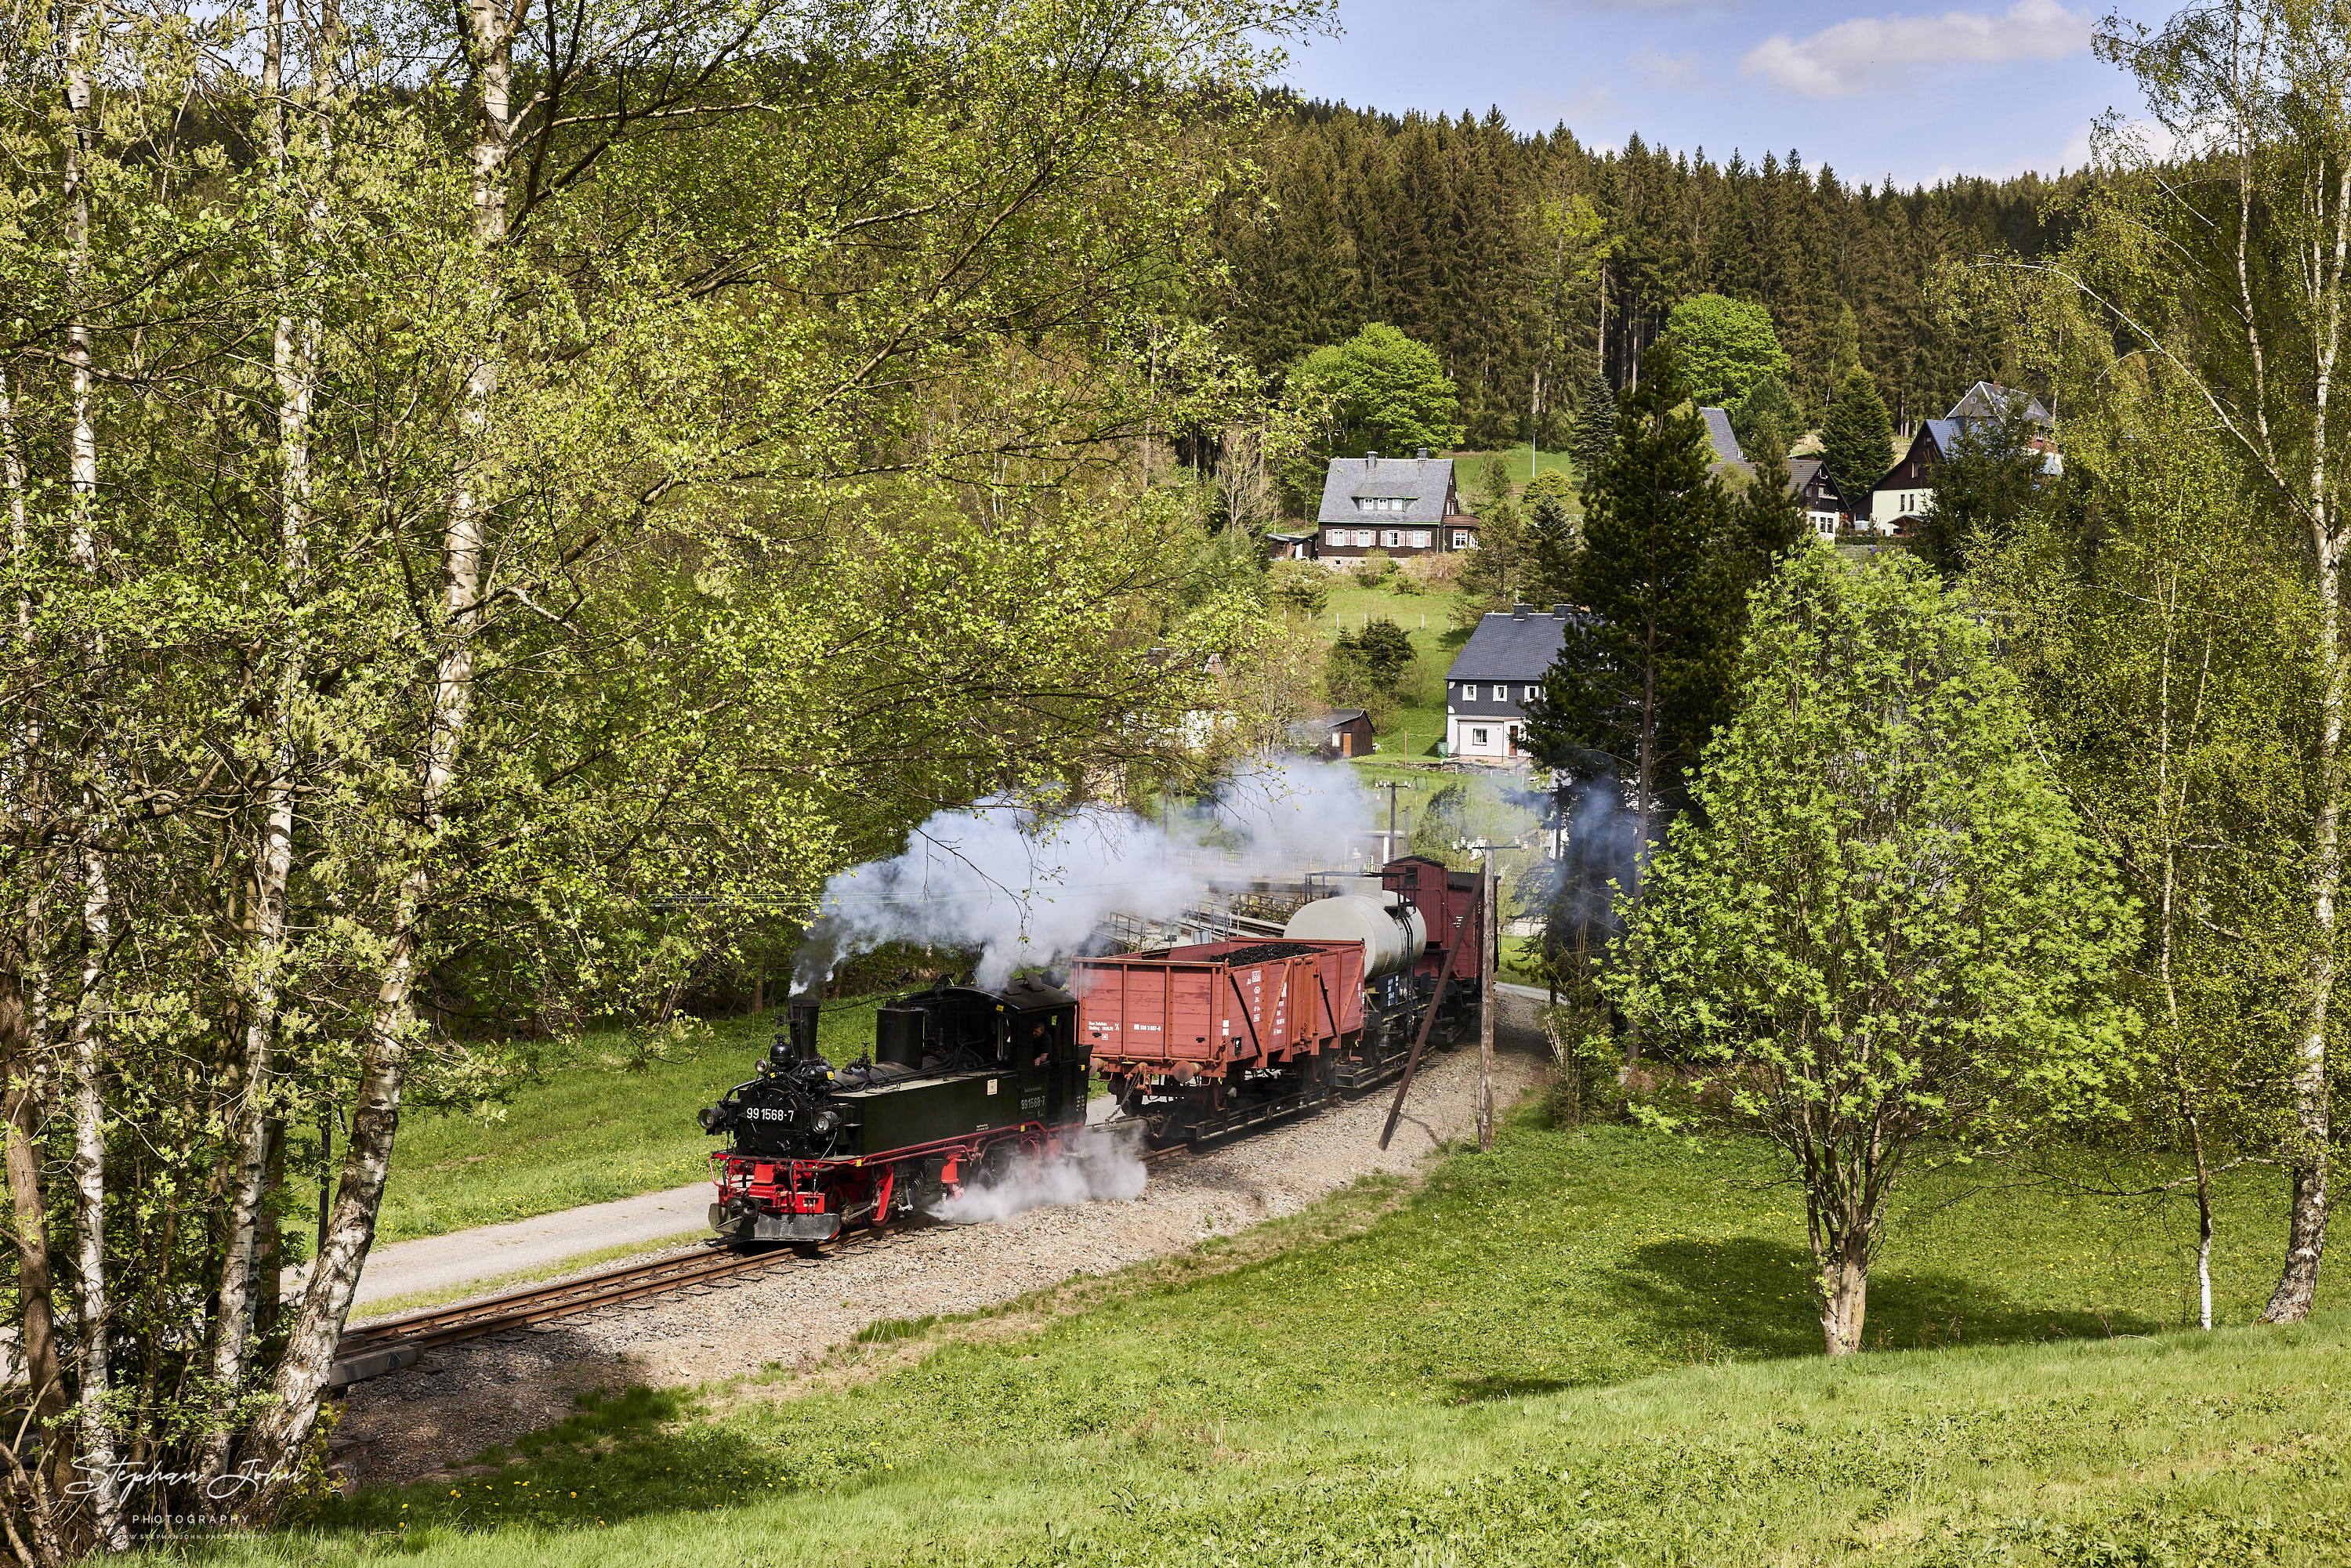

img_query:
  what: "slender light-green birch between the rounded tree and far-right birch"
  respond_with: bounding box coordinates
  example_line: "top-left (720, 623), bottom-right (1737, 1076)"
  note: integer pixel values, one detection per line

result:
top-left (1968, 364), bottom-right (2316, 1328)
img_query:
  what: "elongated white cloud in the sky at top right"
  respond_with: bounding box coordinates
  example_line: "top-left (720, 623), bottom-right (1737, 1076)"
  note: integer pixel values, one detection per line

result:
top-left (1740, 0), bottom-right (2090, 99)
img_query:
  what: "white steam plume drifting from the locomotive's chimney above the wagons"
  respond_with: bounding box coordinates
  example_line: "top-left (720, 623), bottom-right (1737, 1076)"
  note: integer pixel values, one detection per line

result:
top-left (792, 762), bottom-right (1371, 992)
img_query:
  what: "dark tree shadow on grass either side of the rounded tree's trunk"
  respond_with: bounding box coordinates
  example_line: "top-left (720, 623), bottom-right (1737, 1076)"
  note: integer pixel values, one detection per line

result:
top-left (1617, 1237), bottom-right (2161, 1361)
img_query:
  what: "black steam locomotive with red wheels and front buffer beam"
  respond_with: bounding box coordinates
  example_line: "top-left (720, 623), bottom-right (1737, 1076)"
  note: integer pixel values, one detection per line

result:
top-left (701, 980), bottom-right (1089, 1241)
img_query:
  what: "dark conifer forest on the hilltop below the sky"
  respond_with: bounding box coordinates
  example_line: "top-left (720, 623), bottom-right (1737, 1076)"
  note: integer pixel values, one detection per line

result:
top-left (1199, 103), bottom-right (2081, 447)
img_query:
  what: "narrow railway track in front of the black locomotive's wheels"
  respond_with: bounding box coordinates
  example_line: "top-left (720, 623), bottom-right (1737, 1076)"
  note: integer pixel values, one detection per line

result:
top-left (327, 1145), bottom-right (1194, 1387)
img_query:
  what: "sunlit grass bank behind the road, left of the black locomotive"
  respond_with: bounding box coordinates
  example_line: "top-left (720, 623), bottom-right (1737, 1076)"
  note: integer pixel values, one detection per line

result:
top-left (327, 999), bottom-right (912, 1244)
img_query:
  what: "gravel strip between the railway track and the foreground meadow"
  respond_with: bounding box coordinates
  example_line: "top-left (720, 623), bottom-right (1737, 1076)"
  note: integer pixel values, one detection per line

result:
top-left (336, 987), bottom-right (1547, 1483)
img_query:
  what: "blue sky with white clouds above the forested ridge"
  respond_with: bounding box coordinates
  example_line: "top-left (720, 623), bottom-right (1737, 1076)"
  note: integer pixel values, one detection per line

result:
top-left (1286, 0), bottom-right (2170, 186)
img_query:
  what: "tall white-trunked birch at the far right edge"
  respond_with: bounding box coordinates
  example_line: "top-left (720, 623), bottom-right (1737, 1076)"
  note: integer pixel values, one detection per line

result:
top-left (2043, 0), bottom-right (2351, 1324)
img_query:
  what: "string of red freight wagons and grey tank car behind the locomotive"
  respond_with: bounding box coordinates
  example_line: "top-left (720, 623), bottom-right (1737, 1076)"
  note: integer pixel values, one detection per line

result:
top-left (1070, 856), bottom-right (1483, 1143)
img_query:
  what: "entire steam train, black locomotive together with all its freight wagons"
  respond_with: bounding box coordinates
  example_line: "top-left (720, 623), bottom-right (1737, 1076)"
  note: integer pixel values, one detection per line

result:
top-left (701, 856), bottom-right (1491, 1244)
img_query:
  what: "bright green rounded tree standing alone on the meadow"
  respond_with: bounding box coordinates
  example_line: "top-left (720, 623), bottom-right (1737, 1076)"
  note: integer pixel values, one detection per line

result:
top-left (1603, 550), bottom-right (2132, 1356)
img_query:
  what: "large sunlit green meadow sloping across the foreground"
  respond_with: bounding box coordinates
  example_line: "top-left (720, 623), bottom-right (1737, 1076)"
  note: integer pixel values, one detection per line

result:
top-left (216, 1112), bottom-right (2351, 1568)
